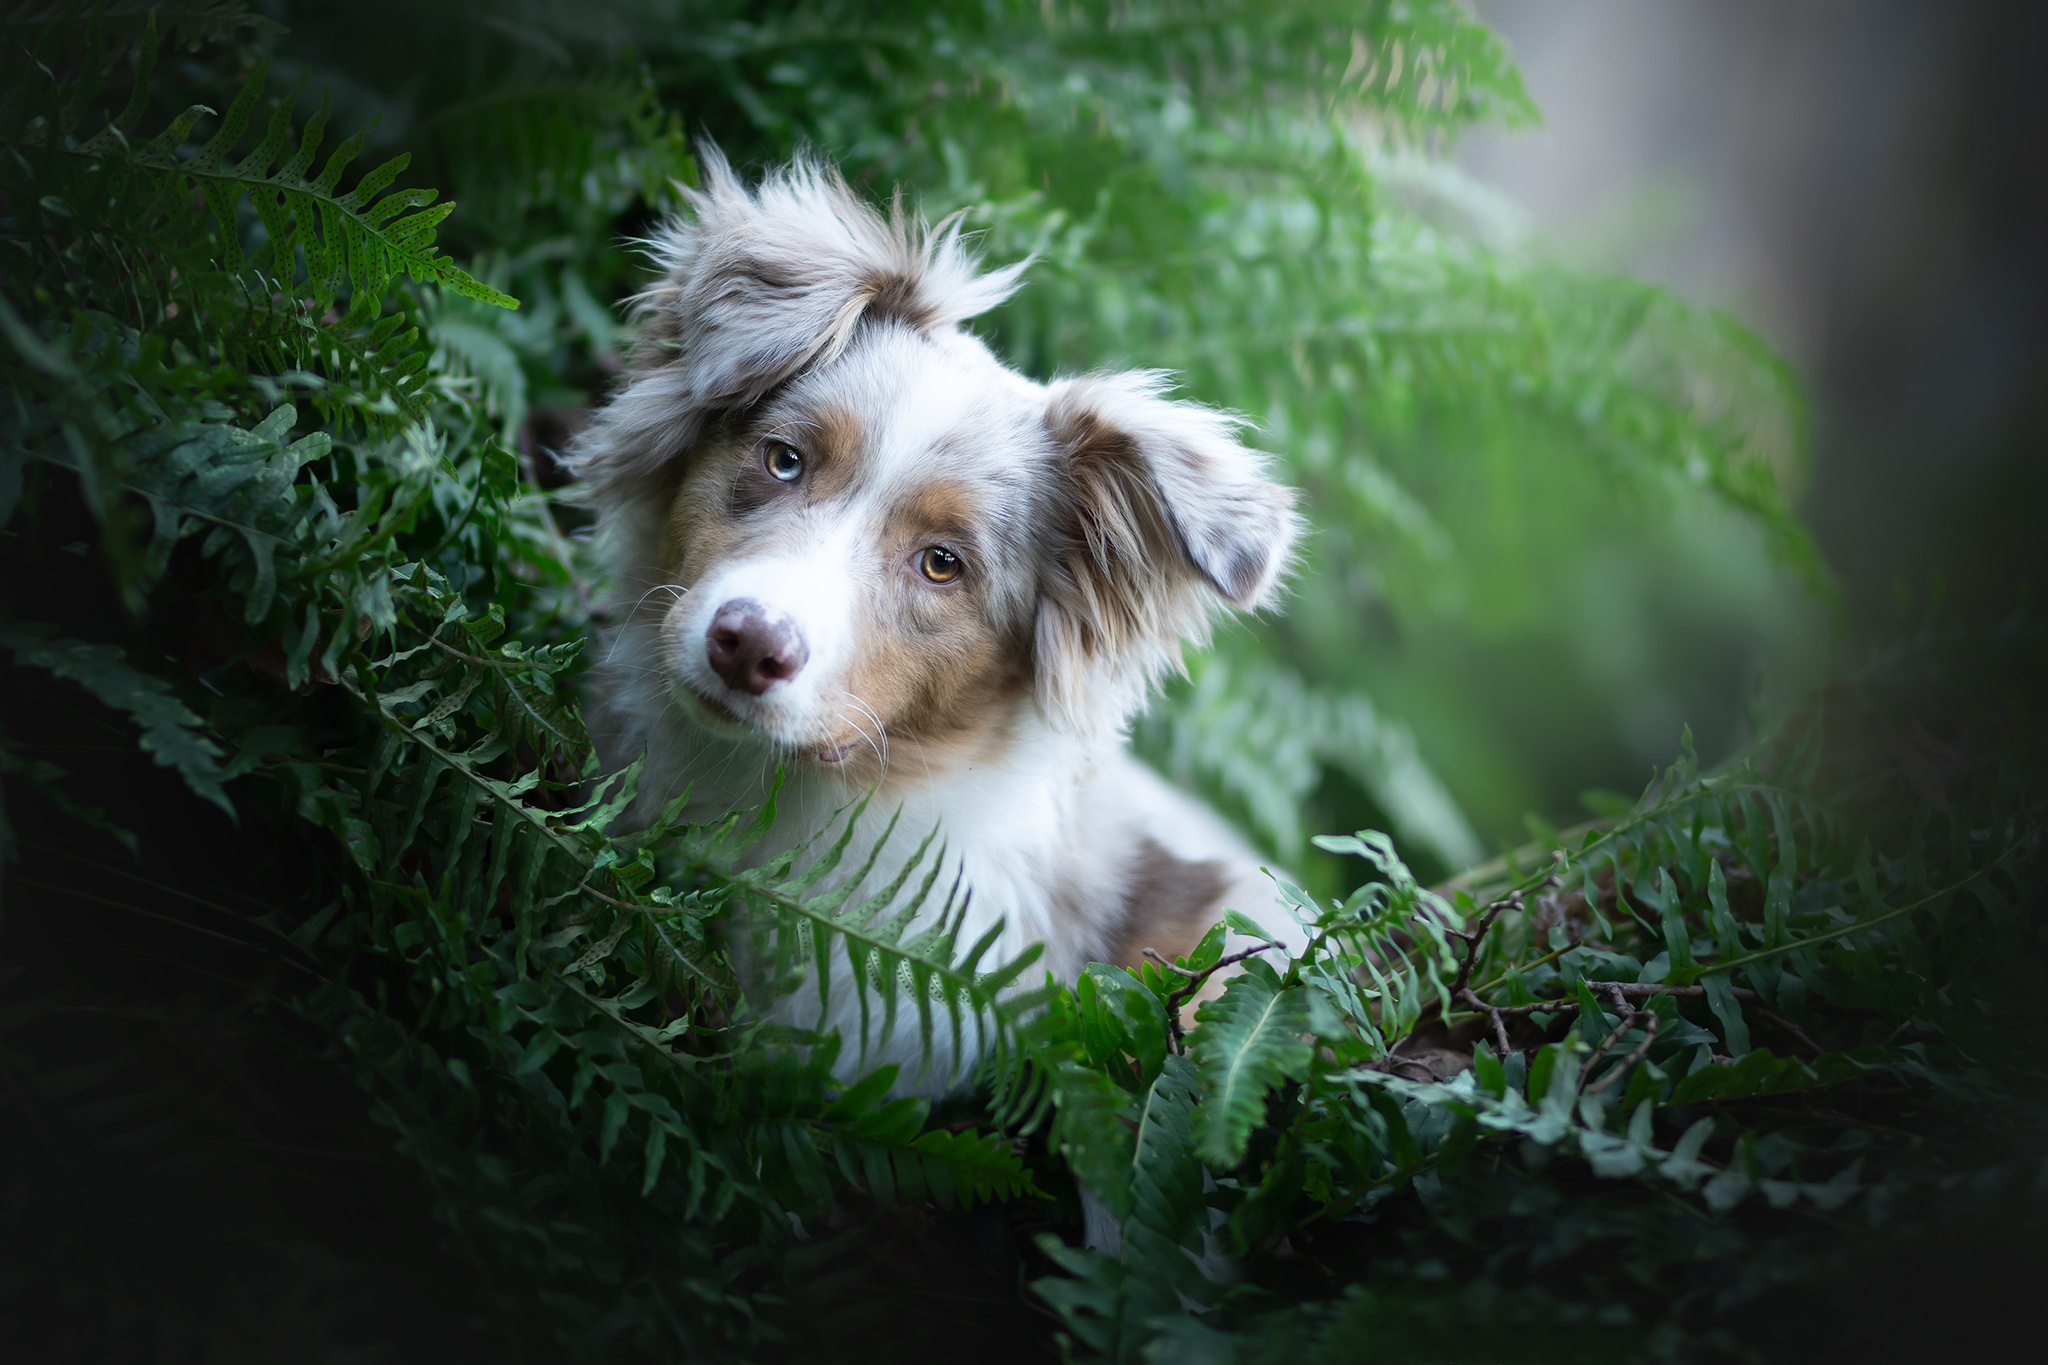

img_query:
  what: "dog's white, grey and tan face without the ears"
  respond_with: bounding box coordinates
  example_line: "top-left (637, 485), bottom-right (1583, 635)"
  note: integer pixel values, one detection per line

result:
top-left (659, 325), bottom-right (1051, 782)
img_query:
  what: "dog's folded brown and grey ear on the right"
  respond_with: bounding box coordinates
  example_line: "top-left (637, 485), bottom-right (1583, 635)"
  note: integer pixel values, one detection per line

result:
top-left (1036, 372), bottom-right (1300, 718)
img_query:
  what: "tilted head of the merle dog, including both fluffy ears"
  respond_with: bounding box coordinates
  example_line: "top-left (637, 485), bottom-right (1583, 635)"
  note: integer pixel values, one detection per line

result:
top-left (571, 153), bottom-right (1296, 780)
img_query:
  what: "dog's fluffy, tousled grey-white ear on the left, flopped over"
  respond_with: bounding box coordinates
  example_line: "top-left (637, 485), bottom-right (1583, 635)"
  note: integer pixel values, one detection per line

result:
top-left (569, 145), bottom-right (1030, 505)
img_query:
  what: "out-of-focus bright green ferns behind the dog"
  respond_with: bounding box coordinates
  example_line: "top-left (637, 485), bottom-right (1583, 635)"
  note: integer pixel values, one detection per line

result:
top-left (264, 0), bottom-right (1827, 890)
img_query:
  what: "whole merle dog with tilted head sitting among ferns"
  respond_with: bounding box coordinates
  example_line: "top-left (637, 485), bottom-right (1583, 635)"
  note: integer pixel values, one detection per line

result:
top-left (565, 149), bottom-right (1300, 1091)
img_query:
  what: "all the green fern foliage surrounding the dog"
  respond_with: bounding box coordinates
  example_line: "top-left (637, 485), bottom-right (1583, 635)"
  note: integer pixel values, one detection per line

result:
top-left (0, 0), bottom-right (2048, 1361)
